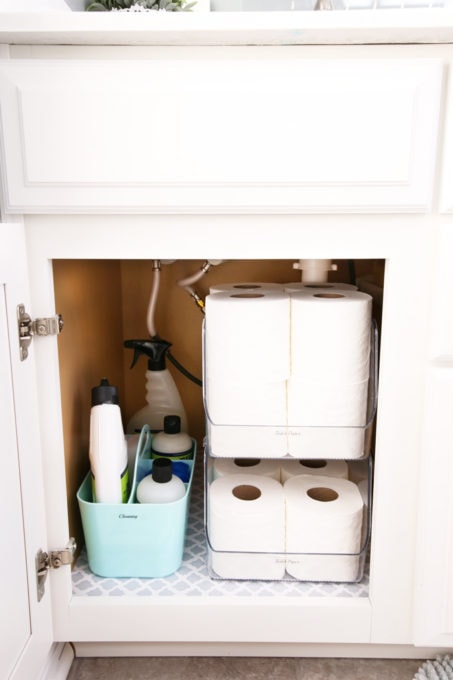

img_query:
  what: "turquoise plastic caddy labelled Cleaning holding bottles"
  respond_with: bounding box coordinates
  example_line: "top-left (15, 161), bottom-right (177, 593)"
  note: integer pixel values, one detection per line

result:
top-left (77, 426), bottom-right (196, 578)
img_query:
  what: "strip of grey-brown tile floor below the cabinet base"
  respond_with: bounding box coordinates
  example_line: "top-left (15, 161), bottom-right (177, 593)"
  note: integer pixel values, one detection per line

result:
top-left (67, 657), bottom-right (423, 680)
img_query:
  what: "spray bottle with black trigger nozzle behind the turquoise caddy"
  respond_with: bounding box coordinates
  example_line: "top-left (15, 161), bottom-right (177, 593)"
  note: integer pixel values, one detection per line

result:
top-left (124, 337), bottom-right (187, 434)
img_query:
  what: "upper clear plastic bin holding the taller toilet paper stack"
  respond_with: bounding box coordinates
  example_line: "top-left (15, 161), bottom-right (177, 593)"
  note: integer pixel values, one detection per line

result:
top-left (203, 321), bottom-right (378, 459)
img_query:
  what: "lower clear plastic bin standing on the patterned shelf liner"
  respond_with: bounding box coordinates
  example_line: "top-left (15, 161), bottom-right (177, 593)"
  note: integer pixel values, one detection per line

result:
top-left (205, 455), bottom-right (372, 583)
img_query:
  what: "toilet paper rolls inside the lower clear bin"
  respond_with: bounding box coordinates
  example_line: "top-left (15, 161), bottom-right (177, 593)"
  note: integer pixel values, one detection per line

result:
top-left (207, 459), bottom-right (367, 582)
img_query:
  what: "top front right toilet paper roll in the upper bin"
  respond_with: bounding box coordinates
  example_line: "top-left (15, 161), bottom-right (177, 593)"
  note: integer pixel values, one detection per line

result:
top-left (290, 288), bottom-right (372, 385)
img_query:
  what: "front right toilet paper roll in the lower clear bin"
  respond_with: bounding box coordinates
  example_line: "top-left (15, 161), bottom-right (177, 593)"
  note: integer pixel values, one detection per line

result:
top-left (283, 475), bottom-right (363, 581)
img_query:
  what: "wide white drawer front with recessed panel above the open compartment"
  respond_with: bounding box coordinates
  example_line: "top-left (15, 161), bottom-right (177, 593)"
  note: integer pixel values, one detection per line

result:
top-left (0, 56), bottom-right (442, 213)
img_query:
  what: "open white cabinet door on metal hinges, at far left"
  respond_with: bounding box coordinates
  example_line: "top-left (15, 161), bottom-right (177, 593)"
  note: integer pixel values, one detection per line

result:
top-left (0, 224), bottom-right (52, 680)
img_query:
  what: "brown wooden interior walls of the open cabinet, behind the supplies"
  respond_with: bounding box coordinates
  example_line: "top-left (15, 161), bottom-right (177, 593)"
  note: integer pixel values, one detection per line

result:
top-left (52, 259), bottom-right (385, 594)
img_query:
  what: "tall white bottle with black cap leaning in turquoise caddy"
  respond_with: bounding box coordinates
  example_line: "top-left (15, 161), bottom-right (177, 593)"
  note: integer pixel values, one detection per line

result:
top-left (89, 378), bottom-right (129, 503)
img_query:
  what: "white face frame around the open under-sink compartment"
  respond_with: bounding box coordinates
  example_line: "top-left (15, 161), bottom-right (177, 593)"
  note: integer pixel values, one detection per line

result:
top-left (21, 215), bottom-right (438, 653)
